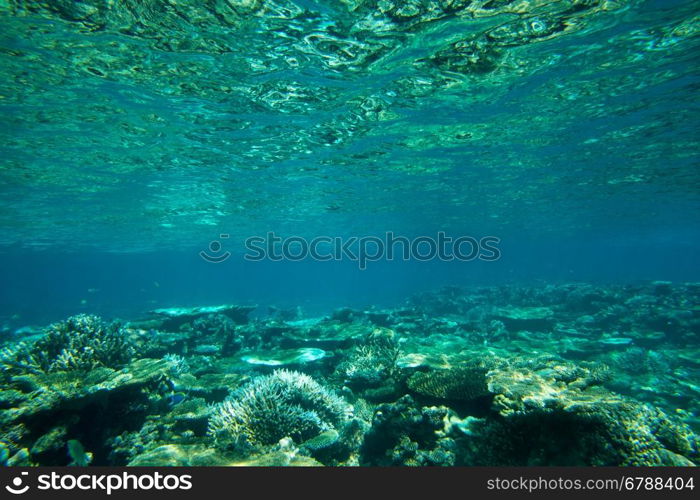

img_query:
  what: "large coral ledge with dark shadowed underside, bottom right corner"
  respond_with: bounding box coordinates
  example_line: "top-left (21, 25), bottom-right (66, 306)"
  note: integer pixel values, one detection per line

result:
top-left (454, 358), bottom-right (698, 466)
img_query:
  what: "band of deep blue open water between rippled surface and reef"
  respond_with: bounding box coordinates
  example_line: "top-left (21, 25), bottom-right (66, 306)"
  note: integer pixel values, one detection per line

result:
top-left (0, 231), bottom-right (700, 328)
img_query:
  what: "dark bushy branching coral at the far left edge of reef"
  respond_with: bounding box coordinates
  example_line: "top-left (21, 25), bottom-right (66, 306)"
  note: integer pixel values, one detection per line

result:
top-left (0, 314), bottom-right (134, 375)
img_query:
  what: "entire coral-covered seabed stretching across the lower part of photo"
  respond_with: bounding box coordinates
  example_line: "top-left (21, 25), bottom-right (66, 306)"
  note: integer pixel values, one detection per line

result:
top-left (0, 282), bottom-right (700, 466)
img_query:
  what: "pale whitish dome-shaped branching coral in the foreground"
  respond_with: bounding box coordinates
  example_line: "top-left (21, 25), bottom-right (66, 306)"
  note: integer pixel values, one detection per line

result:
top-left (209, 370), bottom-right (352, 449)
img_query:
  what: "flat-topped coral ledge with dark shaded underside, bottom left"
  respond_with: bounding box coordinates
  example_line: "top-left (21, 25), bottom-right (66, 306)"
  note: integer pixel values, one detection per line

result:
top-left (0, 359), bottom-right (174, 465)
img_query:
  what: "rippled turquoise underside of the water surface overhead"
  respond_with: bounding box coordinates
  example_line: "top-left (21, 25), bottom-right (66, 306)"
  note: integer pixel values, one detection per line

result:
top-left (0, 0), bottom-right (700, 252)
